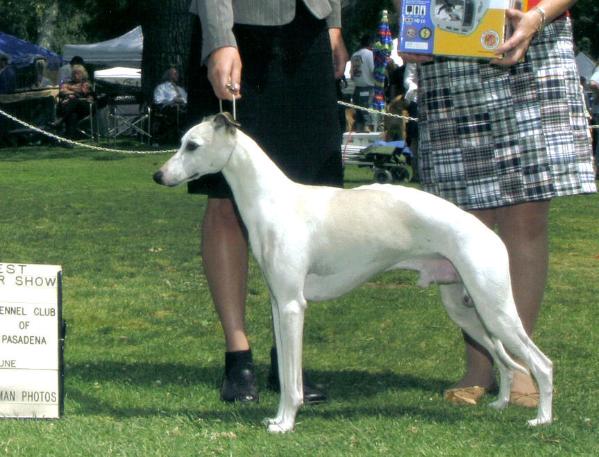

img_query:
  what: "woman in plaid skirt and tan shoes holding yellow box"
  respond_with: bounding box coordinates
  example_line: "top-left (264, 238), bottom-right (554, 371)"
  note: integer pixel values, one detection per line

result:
top-left (396, 0), bottom-right (596, 407)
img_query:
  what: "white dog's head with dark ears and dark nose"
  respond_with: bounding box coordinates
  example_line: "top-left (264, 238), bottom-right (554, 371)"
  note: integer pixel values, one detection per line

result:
top-left (154, 113), bottom-right (239, 186)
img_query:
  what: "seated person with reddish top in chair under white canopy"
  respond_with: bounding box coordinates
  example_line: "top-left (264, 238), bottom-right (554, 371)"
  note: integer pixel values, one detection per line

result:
top-left (52, 65), bottom-right (94, 138)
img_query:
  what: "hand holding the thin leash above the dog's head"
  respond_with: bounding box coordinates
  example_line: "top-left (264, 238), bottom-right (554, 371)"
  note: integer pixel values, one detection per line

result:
top-left (208, 46), bottom-right (242, 100)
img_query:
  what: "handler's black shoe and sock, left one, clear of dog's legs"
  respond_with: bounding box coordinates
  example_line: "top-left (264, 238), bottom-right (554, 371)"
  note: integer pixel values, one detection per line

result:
top-left (220, 350), bottom-right (259, 403)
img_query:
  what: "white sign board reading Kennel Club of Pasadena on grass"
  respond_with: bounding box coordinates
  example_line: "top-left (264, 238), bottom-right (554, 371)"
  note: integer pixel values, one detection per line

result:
top-left (0, 263), bottom-right (63, 418)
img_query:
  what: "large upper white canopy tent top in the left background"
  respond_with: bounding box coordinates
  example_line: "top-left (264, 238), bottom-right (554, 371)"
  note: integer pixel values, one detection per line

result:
top-left (62, 26), bottom-right (143, 68)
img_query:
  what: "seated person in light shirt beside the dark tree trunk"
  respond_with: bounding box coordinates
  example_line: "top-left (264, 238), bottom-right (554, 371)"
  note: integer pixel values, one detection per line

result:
top-left (154, 67), bottom-right (187, 141)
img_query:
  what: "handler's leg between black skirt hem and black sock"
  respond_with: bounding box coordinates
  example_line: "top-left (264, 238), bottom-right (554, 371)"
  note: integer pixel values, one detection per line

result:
top-left (202, 198), bottom-right (250, 352)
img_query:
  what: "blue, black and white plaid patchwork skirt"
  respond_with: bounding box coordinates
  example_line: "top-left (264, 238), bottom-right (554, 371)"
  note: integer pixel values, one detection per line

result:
top-left (418, 17), bottom-right (596, 210)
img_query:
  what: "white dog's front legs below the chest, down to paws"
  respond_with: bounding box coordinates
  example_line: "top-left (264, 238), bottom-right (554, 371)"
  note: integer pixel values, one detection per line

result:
top-left (267, 296), bottom-right (306, 433)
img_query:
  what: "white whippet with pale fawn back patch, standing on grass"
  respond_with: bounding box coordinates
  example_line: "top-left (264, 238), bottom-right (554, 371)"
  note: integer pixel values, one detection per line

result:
top-left (154, 114), bottom-right (553, 432)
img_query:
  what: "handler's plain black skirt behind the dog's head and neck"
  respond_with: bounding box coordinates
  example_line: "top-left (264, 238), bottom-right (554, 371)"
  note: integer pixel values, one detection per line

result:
top-left (188, 2), bottom-right (343, 198)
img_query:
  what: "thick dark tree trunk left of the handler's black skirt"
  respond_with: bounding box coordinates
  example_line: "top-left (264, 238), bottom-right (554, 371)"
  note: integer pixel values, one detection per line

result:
top-left (138, 0), bottom-right (192, 102)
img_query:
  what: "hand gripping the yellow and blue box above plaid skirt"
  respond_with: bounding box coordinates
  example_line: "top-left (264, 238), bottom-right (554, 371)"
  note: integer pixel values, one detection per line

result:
top-left (491, 9), bottom-right (542, 66)
